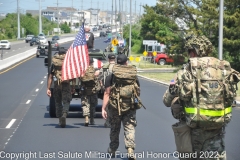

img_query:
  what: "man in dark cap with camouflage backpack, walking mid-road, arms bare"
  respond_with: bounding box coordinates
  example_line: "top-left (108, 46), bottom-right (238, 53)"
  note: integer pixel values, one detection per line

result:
top-left (102, 54), bottom-right (141, 160)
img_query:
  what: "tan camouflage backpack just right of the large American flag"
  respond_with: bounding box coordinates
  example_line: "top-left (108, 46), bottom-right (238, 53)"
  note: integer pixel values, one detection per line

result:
top-left (81, 65), bottom-right (101, 95)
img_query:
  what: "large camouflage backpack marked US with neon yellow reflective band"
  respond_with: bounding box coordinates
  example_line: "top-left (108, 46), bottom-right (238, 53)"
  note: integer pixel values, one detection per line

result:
top-left (179, 57), bottom-right (239, 130)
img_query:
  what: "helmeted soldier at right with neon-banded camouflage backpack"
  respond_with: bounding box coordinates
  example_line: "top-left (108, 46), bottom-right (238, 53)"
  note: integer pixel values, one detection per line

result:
top-left (163, 35), bottom-right (239, 160)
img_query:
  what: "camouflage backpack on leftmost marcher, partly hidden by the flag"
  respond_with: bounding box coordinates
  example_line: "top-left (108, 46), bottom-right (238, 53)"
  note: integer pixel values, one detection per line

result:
top-left (52, 54), bottom-right (66, 84)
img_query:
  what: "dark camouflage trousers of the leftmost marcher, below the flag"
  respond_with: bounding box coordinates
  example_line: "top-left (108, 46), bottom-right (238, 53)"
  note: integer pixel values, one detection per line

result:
top-left (53, 81), bottom-right (72, 117)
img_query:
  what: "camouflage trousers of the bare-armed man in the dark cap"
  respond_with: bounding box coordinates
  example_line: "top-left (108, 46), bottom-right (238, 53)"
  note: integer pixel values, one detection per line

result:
top-left (108, 105), bottom-right (137, 151)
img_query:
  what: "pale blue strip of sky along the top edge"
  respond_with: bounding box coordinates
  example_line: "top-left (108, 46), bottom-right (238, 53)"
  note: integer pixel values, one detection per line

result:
top-left (0, 0), bottom-right (156, 14)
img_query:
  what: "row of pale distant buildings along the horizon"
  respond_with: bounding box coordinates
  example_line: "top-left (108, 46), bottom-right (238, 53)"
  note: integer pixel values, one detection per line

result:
top-left (26, 7), bottom-right (134, 28)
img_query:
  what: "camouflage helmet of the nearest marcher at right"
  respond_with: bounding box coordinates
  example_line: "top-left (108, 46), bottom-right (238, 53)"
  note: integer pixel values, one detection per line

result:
top-left (185, 34), bottom-right (212, 57)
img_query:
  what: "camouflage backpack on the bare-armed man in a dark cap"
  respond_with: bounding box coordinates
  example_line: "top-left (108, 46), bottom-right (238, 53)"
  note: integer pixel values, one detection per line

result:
top-left (109, 64), bottom-right (143, 115)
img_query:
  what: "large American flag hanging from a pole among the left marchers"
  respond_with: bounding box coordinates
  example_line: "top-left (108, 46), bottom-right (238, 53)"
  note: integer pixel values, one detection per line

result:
top-left (62, 25), bottom-right (89, 81)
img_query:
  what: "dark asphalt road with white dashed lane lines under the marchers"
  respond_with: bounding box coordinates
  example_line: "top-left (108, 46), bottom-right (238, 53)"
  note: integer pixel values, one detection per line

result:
top-left (0, 34), bottom-right (240, 160)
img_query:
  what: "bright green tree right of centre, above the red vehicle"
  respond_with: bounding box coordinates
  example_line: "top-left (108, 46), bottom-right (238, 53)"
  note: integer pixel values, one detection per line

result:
top-left (141, 0), bottom-right (186, 54)
